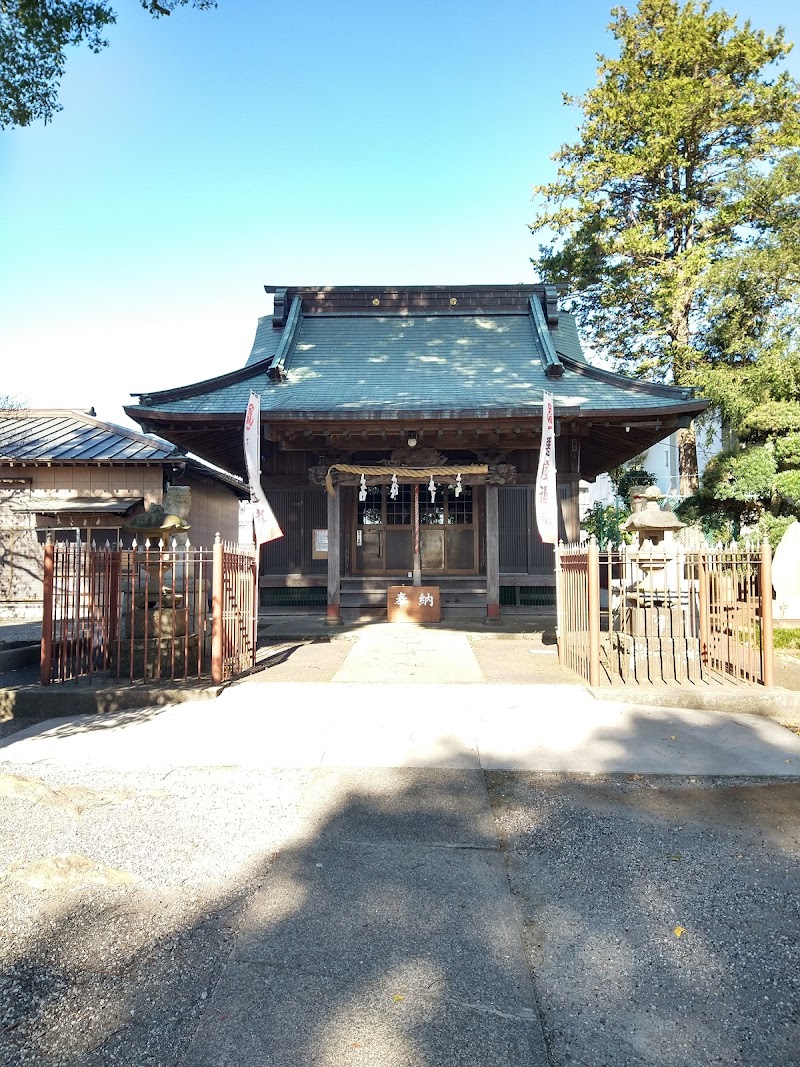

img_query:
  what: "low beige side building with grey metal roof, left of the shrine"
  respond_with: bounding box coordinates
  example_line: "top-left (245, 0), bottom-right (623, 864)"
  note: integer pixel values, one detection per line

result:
top-left (0, 409), bottom-right (247, 616)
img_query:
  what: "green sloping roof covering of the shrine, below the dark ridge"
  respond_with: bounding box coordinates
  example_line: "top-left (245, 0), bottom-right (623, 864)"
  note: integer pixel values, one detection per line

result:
top-left (128, 312), bottom-right (692, 419)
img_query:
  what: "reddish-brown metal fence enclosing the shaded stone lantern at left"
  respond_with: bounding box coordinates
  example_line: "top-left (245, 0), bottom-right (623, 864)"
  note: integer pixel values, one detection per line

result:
top-left (41, 538), bottom-right (256, 685)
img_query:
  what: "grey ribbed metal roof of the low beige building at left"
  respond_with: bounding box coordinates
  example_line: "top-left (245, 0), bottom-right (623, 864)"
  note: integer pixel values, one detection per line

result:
top-left (0, 409), bottom-right (181, 463)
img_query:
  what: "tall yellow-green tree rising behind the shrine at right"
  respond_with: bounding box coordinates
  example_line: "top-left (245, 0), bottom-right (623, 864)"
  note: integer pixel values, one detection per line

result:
top-left (531, 0), bottom-right (800, 484)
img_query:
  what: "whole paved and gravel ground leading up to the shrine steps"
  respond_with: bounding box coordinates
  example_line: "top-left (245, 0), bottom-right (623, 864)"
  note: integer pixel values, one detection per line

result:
top-left (0, 628), bottom-right (800, 1067)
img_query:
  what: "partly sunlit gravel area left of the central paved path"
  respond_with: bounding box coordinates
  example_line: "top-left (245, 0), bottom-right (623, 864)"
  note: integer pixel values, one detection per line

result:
top-left (0, 765), bottom-right (310, 1067)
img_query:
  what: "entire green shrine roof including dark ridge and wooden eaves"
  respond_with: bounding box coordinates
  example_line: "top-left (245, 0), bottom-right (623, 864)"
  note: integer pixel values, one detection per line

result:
top-left (125, 285), bottom-right (706, 477)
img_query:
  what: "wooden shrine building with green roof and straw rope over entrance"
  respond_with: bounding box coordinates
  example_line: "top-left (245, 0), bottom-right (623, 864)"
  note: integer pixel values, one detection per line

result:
top-left (126, 284), bottom-right (706, 621)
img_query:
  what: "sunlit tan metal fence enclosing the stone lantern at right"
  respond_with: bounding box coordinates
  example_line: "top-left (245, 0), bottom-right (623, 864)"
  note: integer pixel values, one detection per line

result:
top-left (556, 542), bottom-right (774, 686)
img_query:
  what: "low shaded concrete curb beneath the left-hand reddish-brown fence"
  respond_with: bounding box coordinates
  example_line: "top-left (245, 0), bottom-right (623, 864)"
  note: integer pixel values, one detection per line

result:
top-left (0, 683), bottom-right (223, 722)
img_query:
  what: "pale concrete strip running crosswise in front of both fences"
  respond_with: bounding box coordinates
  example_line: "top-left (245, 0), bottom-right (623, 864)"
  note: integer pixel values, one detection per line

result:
top-left (0, 683), bottom-right (800, 776)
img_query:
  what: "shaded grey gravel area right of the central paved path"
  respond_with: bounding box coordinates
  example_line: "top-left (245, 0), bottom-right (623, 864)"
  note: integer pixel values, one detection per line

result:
top-left (487, 773), bottom-right (800, 1067)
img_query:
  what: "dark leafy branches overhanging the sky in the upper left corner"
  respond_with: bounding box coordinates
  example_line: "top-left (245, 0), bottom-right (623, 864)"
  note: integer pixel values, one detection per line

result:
top-left (0, 0), bottom-right (217, 128)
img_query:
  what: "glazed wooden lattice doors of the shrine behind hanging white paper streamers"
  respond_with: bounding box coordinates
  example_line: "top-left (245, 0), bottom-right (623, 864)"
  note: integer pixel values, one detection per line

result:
top-left (351, 484), bottom-right (478, 577)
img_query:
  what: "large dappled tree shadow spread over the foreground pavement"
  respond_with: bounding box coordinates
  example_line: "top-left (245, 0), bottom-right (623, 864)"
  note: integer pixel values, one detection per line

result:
top-left (0, 751), bottom-right (800, 1067)
